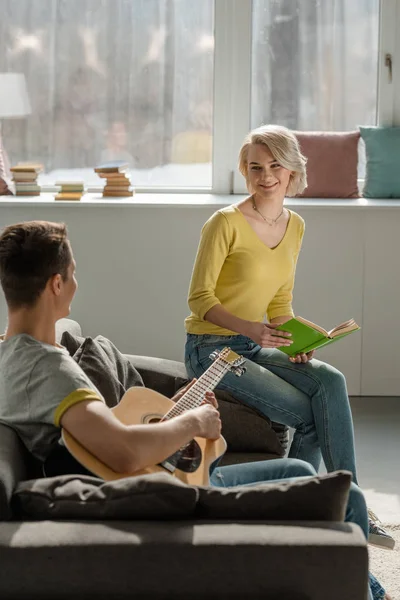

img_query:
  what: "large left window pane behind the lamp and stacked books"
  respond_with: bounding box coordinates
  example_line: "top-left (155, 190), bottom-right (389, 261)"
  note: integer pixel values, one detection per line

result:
top-left (0, 0), bottom-right (214, 187)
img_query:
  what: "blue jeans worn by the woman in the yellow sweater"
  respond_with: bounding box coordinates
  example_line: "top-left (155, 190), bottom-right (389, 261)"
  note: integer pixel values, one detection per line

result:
top-left (185, 334), bottom-right (357, 483)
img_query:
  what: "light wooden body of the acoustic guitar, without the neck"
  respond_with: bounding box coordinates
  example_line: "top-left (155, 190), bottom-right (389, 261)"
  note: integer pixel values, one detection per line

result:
top-left (62, 387), bottom-right (226, 485)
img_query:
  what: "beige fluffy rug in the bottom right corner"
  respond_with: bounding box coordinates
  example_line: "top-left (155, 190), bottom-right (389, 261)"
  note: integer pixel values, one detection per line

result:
top-left (368, 524), bottom-right (400, 600)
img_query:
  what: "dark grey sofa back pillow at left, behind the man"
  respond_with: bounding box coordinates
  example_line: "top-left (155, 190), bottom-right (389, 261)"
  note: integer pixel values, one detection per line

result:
top-left (12, 473), bottom-right (198, 520)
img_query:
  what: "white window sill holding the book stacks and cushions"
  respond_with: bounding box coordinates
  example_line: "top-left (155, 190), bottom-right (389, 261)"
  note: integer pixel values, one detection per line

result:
top-left (0, 192), bottom-right (400, 210)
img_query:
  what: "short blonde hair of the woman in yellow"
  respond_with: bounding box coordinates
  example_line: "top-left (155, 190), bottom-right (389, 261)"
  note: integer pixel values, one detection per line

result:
top-left (239, 125), bottom-right (307, 196)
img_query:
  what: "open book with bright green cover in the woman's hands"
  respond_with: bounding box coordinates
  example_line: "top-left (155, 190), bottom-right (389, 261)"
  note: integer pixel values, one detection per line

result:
top-left (276, 317), bottom-right (360, 356)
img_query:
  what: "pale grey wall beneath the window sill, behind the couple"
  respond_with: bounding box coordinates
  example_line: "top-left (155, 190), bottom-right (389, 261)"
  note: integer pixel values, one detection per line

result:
top-left (0, 195), bottom-right (400, 395)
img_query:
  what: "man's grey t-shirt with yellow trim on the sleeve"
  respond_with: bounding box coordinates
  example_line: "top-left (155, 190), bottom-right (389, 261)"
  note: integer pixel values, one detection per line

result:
top-left (0, 334), bottom-right (104, 460)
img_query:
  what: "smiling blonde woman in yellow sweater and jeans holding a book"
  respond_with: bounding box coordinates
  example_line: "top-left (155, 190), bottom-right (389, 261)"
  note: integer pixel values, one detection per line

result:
top-left (185, 125), bottom-right (394, 548)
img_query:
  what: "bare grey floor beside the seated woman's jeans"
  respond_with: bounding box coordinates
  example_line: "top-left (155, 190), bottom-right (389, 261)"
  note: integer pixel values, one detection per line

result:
top-left (350, 396), bottom-right (400, 523)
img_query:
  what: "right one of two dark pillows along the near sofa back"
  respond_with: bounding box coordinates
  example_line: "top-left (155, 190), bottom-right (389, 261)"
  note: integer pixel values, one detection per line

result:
top-left (196, 471), bottom-right (351, 521)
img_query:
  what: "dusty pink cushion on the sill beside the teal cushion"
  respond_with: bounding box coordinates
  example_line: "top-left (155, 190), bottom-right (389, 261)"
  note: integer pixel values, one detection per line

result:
top-left (295, 131), bottom-right (360, 198)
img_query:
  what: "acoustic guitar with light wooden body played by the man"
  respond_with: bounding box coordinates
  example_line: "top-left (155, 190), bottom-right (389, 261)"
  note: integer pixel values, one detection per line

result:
top-left (61, 348), bottom-right (246, 485)
